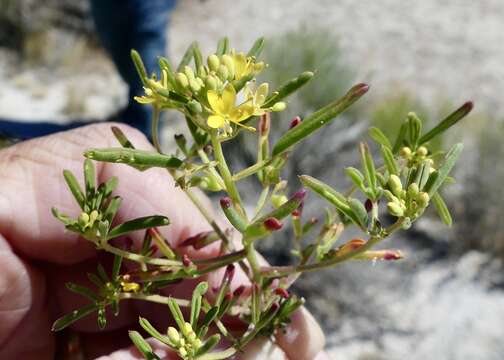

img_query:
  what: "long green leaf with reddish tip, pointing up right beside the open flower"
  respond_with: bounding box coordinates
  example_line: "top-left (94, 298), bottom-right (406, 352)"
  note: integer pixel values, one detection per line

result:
top-left (272, 84), bottom-right (369, 156)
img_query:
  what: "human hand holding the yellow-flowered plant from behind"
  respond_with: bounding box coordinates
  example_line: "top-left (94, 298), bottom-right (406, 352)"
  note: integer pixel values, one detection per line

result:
top-left (0, 124), bottom-right (326, 360)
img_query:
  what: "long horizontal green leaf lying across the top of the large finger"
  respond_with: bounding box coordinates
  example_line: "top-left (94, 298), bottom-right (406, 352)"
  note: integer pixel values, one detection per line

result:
top-left (84, 148), bottom-right (182, 169)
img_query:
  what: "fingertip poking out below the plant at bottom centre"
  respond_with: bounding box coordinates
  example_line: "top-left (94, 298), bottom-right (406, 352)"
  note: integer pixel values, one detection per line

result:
top-left (277, 307), bottom-right (325, 360)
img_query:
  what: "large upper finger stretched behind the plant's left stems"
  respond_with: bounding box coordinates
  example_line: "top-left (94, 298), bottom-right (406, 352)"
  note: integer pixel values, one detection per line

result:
top-left (0, 123), bottom-right (215, 263)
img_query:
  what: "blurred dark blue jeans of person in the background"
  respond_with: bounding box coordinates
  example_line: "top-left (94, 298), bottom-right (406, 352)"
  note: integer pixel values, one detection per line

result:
top-left (0, 0), bottom-right (176, 139)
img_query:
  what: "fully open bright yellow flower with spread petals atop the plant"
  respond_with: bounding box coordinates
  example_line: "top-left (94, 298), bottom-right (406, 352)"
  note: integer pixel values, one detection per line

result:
top-left (207, 83), bottom-right (255, 131)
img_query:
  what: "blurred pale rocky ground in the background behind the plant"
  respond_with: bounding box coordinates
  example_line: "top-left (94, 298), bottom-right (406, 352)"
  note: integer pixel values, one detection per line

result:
top-left (0, 0), bottom-right (504, 360)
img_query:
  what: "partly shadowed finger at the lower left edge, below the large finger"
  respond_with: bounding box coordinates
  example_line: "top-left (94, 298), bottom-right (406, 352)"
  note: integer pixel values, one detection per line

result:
top-left (0, 236), bottom-right (54, 359)
